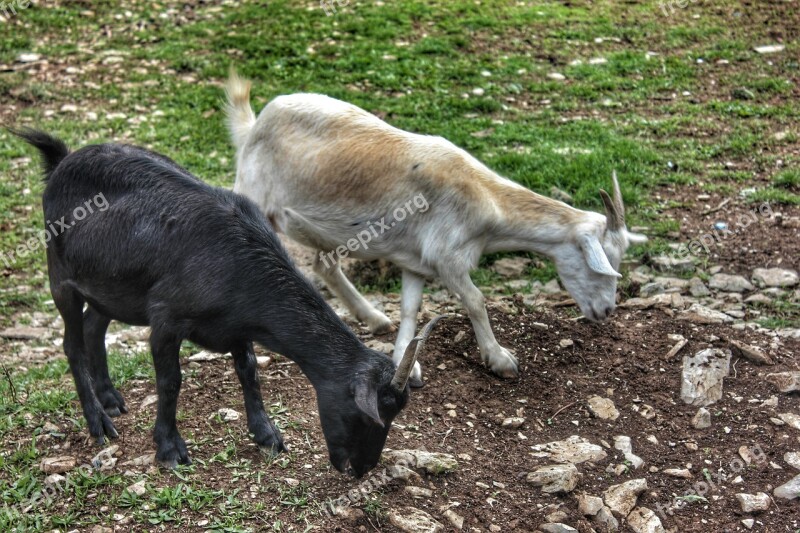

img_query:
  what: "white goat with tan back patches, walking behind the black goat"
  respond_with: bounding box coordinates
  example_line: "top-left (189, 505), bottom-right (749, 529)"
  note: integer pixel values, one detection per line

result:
top-left (227, 73), bottom-right (646, 386)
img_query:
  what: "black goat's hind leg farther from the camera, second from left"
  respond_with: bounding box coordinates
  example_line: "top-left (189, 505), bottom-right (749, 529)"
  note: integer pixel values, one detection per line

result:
top-left (83, 306), bottom-right (128, 417)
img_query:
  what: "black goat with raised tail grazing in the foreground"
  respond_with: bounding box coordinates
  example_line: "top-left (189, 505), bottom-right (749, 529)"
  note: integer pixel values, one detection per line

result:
top-left (14, 130), bottom-right (432, 477)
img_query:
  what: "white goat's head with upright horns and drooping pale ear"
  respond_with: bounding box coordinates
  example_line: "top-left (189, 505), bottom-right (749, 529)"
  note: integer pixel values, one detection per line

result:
top-left (554, 172), bottom-right (647, 322)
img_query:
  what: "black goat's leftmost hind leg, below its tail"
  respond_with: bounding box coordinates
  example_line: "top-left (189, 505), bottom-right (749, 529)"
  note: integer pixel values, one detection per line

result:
top-left (52, 286), bottom-right (117, 445)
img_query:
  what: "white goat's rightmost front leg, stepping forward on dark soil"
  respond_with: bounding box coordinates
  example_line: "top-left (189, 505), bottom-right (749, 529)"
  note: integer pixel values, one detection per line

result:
top-left (440, 270), bottom-right (519, 378)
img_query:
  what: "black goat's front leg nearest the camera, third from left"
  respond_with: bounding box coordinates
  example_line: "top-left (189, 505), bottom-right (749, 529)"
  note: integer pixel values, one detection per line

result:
top-left (150, 329), bottom-right (192, 468)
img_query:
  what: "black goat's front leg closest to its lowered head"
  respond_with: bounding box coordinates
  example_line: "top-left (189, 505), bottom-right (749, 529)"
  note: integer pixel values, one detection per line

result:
top-left (231, 343), bottom-right (287, 454)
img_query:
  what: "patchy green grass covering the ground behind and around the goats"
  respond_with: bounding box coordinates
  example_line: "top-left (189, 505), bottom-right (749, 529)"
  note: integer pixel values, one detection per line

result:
top-left (0, 0), bottom-right (800, 531)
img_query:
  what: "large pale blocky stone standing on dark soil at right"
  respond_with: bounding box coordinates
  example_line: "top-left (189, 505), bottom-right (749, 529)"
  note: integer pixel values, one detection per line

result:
top-left (681, 348), bottom-right (731, 407)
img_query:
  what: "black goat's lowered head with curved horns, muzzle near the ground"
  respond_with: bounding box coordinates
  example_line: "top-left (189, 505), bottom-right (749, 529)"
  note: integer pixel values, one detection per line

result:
top-left (317, 316), bottom-right (442, 478)
